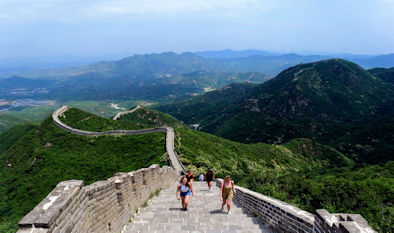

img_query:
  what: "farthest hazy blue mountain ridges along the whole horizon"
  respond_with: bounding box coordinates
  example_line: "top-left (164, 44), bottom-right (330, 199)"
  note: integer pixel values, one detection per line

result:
top-left (0, 49), bottom-right (394, 78)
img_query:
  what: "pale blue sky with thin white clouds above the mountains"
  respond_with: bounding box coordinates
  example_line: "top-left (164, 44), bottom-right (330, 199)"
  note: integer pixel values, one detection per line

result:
top-left (0, 0), bottom-right (394, 59)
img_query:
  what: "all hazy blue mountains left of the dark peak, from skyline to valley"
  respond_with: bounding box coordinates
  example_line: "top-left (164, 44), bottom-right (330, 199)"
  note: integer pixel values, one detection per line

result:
top-left (0, 50), bottom-right (394, 101)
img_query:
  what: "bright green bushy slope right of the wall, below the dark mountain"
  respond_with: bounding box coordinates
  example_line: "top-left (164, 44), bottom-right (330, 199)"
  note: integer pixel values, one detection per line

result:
top-left (175, 129), bottom-right (394, 232)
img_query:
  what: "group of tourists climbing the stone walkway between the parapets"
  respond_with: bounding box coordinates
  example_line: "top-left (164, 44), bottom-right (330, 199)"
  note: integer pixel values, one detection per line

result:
top-left (176, 170), bottom-right (235, 214)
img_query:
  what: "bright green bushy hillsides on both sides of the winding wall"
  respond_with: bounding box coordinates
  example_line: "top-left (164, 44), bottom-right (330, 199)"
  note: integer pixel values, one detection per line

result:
top-left (0, 107), bottom-right (393, 232)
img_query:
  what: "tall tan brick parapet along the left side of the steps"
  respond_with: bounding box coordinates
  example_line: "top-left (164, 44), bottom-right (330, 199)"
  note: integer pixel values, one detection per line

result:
top-left (17, 164), bottom-right (179, 233)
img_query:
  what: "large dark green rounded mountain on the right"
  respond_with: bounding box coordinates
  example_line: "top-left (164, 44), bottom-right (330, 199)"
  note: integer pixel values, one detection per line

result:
top-left (158, 59), bottom-right (394, 163)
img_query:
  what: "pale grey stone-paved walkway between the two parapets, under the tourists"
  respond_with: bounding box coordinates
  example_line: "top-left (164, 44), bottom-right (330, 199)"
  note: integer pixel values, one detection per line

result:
top-left (123, 182), bottom-right (270, 233)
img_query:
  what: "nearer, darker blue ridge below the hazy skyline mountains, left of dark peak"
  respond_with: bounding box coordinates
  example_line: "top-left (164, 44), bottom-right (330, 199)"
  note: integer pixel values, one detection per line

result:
top-left (0, 71), bottom-right (270, 101)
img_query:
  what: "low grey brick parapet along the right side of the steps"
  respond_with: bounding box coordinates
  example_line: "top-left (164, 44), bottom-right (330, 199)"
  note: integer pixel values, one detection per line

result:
top-left (216, 178), bottom-right (375, 233)
